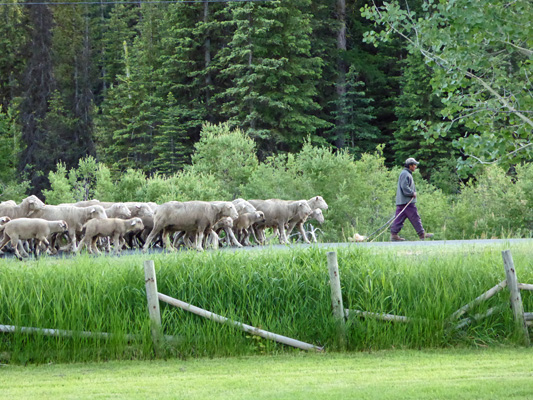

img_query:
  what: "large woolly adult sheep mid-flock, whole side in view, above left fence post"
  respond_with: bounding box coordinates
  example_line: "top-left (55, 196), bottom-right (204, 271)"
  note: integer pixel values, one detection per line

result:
top-left (143, 201), bottom-right (238, 251)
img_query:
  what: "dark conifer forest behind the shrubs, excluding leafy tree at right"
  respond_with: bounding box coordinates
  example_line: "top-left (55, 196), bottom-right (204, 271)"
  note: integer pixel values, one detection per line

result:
top-left (0, 0), bottom-right (461, 196)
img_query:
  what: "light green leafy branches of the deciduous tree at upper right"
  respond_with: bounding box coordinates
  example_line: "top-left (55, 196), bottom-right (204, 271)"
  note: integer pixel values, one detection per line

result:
top-left (362, 0), bottom-right (533, 171)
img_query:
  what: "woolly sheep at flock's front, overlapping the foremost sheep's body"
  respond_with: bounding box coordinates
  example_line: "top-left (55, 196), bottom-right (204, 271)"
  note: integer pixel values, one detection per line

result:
top-left (249, 199), bottom-right (312, 244)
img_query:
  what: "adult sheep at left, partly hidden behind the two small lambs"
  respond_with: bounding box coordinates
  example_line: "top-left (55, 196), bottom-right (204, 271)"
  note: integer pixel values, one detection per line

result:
top-left (30, 206), bottom-right (107, 251)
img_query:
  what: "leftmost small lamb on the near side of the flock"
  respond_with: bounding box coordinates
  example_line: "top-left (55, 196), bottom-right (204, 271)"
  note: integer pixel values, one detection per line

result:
top-left (0, 218), bottom-right (68, 260)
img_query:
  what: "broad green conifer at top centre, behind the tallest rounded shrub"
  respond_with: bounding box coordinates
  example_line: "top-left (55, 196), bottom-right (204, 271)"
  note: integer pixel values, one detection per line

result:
top-left (220, 0), bottom-right (327, 153)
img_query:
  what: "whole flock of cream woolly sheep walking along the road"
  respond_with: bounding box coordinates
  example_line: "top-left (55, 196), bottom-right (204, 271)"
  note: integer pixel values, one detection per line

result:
top-left (0, 196), bottom-right (328, 259)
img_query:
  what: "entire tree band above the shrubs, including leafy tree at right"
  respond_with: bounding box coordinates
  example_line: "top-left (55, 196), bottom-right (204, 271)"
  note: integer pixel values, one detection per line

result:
top-left (0, 0), bottom-right (533, 201)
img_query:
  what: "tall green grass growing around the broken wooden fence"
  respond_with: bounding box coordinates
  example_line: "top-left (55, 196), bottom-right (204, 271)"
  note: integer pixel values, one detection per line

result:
top-left (0, 245), bottom-right (533, 363)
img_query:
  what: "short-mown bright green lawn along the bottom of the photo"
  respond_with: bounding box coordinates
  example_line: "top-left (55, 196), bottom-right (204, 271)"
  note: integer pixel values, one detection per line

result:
top-left (0, 348), bottom-right (533, 400)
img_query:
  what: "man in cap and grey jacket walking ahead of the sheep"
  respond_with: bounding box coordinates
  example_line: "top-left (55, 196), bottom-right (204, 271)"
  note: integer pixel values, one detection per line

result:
top-left (390, 158), bottom-right (433, 242)
